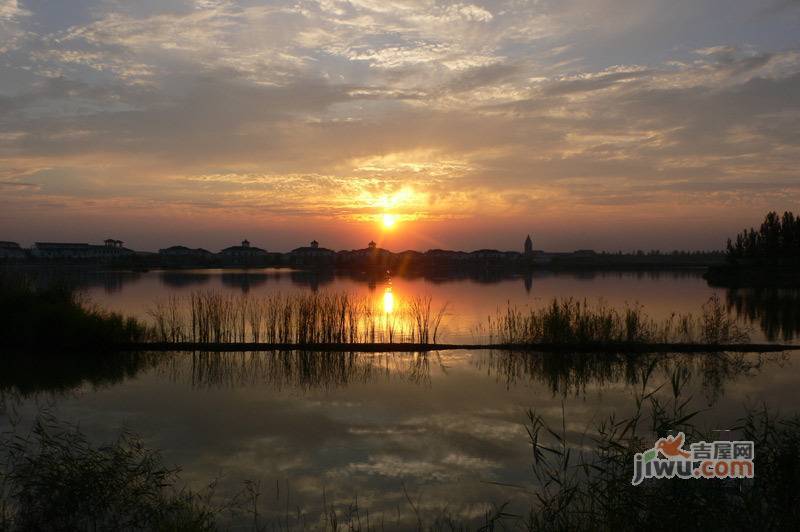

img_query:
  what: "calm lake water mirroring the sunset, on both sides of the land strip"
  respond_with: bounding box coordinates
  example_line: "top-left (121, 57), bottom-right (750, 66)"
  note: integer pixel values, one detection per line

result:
top-left (0, 270), bottom-right (800, 528)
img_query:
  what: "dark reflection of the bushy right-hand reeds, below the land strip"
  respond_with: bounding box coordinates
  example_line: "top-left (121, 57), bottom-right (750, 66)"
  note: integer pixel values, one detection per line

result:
top-left (477, 351), bottom-right (785, 400)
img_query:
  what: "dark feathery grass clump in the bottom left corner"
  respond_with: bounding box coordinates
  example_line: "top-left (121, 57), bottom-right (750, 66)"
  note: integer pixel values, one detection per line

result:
top-left (0, 418), bottom-right (215, 531)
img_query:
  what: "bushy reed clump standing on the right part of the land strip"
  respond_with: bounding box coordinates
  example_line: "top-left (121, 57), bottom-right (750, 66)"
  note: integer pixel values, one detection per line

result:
top-left (487, 296), bottom-right (749, 345)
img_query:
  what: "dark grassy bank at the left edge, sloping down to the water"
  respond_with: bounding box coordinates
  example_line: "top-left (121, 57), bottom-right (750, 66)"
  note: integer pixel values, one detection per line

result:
top-left (0, 273), bottom-right (147, 352)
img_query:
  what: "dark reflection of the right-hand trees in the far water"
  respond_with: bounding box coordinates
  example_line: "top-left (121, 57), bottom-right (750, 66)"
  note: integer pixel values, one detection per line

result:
top-left (727, 288), bottom-right (800, 342)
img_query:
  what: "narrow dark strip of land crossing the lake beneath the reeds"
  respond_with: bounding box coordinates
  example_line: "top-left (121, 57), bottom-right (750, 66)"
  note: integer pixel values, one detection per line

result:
top-left (119, 342), bottom-right (800, 353)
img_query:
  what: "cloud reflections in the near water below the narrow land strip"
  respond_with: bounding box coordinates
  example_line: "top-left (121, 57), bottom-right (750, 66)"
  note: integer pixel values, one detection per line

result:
top-left (1, 351), bottom-right (800, 528)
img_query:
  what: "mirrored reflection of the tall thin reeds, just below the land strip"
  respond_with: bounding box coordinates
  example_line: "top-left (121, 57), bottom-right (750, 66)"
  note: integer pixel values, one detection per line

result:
top-left (166, 351), bottom-right (435, 390)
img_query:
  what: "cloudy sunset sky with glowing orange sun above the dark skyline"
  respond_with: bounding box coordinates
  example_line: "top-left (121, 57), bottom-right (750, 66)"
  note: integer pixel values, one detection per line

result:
top-left (0, 0), bottom-right (800, 251)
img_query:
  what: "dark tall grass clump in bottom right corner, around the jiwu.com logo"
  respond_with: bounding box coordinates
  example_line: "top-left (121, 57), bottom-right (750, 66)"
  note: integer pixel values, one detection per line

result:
top-left (524, 369), bottom-right (800, 531)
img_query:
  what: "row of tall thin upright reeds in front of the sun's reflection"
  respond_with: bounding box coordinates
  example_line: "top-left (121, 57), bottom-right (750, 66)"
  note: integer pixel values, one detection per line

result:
top-left (149, 291), bottom-right (447, 345)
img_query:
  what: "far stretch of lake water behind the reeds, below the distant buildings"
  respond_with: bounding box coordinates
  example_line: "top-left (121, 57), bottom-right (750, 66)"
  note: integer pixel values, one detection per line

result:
top-left (80, 269), bottom-right (800, 342)
